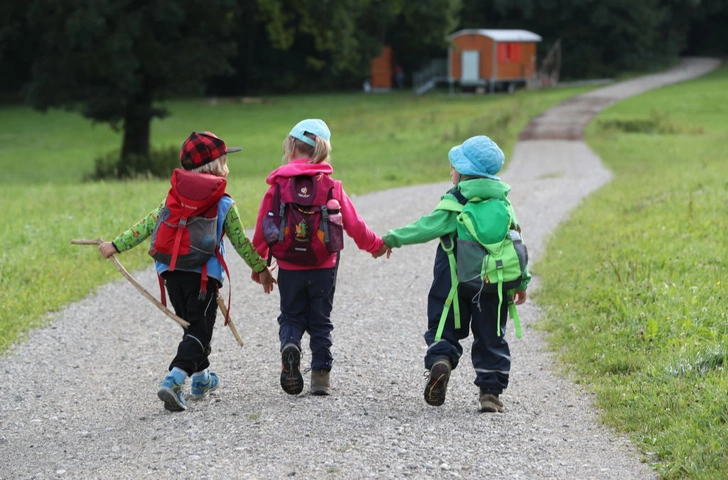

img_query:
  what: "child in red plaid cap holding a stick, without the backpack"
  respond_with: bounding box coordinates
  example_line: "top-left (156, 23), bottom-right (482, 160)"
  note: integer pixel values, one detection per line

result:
top-left (99, 132), bottom-right (276, 411)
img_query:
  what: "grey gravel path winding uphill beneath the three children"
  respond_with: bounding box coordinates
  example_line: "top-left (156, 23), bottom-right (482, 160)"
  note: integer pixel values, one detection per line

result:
top-left (0, 59), bottom-right (717, 480)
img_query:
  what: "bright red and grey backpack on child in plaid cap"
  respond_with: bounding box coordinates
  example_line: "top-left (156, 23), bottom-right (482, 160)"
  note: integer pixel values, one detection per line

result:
top-left (149, 168), bottom-right (230, 318)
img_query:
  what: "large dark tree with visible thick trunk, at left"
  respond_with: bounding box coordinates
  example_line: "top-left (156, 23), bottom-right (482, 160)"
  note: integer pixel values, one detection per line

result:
top-left (27, 0), bottom-right (235, 172)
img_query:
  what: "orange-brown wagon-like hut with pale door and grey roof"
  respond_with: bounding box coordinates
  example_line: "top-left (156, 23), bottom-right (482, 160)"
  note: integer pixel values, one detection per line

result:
top-left (447, 29), bottom-right (541, 92)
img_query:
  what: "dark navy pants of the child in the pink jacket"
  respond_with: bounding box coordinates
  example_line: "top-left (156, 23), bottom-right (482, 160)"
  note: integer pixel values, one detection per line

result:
top-left (278, 268), bottom-right (336, 370)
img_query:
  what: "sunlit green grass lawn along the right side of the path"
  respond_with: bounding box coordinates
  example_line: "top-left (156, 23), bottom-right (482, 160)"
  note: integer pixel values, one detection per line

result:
top-left (535, 62), bottom-right (728, 479)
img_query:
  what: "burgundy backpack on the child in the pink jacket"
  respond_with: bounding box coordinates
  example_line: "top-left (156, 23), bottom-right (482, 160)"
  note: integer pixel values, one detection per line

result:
top-left (263, 173), bottom-right (344, 266)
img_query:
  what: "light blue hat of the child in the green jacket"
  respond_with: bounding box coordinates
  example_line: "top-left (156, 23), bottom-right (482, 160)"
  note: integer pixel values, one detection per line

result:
top-left (447, 135), bottom-right (506, 180)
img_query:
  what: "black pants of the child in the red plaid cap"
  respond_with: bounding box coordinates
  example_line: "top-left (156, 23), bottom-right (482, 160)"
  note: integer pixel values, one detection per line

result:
top-left (162, 270), bottom-right (220, 375)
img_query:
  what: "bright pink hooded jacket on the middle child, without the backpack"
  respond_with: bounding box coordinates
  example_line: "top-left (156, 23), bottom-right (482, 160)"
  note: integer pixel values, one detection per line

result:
top-left (253, 158), bottom-right (384, 270)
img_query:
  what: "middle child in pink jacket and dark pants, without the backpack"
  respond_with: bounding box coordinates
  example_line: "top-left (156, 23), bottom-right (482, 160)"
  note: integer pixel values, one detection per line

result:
top-left (253, 119), bottom-right (387, 395)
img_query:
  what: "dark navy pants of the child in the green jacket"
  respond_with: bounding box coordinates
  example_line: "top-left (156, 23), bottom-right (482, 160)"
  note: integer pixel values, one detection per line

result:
top-left (425, 245), bottom-right (511, 394)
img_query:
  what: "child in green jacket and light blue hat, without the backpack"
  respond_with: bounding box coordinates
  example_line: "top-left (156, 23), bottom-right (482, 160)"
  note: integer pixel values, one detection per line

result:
top-left (382, 135), bottom-right (531, 412)
